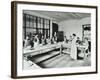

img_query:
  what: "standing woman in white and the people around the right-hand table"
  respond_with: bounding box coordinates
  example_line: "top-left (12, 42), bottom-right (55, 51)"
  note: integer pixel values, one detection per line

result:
top-left (64, 34), bottom-right (90, 59)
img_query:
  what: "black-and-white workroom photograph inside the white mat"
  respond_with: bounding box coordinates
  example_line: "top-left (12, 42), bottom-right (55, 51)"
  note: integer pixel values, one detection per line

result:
top-left (23, 10), bottom-right (91, 69)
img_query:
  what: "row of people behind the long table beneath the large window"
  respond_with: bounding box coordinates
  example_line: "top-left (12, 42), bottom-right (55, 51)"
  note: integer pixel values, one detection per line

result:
top-left (23, 33), bottom-right (57, 48)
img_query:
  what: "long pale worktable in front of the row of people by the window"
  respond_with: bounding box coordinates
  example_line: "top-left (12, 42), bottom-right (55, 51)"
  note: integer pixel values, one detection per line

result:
top-left (23, 42), bottom-right (62, 56)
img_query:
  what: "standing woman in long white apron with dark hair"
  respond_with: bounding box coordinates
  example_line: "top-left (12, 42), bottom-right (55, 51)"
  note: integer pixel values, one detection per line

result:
top-left (70, 34), bottom-right (77, 60)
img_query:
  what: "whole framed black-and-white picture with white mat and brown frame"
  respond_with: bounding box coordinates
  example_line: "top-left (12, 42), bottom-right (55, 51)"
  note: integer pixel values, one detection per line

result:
top-left (12, 1), bottom-right (97, 78)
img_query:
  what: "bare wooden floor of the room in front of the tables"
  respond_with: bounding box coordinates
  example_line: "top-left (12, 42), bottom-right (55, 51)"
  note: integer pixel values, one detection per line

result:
top-left (28, 51), bottom-right (91, 68)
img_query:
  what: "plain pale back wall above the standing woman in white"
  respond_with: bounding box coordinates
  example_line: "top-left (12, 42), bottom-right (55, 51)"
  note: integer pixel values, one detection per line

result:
top-left (59, 17), bottom-right (91, 39)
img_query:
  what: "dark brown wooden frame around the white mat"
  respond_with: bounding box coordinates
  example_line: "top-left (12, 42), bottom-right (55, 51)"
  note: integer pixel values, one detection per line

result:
top-left (11, 1), bottom-right (98, 78)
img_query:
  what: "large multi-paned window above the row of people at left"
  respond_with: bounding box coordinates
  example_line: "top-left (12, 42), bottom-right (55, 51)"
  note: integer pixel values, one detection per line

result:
top-left (23, 13), bottom-right (50, 38)
